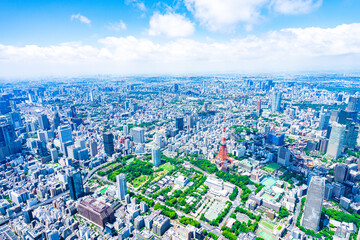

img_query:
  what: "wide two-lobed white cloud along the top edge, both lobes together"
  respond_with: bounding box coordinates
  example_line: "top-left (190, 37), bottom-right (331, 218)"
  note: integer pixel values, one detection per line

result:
top-left (184, 0), bottom-right (322, 31)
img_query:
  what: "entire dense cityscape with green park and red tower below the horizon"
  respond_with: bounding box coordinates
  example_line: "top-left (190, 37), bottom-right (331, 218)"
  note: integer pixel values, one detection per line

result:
top-left (0, 74), bottom-right (360, 240)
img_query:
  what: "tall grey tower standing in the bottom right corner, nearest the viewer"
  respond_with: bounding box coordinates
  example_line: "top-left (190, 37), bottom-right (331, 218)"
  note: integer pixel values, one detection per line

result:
top-left (301, 176), bottom-right (325, 231)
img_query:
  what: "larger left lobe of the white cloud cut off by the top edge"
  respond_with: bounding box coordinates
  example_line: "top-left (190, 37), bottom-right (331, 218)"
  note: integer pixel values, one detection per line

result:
top-left (185, 0), bottom-right (268, 31)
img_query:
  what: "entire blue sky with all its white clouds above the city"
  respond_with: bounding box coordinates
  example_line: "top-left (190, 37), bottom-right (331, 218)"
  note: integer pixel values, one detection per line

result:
top-left (0, 0), bottom-right (360, 77)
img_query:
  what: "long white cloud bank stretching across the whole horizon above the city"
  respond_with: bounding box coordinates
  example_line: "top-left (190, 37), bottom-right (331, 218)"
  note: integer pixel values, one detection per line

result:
top-left (0, 23), bottom-right (360, 77)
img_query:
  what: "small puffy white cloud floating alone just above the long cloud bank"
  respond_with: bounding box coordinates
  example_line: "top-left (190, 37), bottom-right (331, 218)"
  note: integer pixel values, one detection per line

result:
top-left (149, 13), bottom-right (195, 37)
